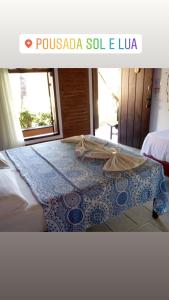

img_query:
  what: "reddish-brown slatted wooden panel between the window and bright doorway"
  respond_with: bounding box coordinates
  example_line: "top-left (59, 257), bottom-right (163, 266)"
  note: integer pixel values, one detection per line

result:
top-left (58, 68), bottom-right (90, 138)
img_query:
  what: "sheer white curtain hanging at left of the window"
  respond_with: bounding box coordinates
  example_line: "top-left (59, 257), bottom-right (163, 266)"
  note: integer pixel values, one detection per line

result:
top-left (0, 69), bottom-right (24, 150)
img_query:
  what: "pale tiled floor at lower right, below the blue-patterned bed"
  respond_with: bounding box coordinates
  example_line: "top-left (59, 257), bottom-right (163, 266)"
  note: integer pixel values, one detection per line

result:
top-left (87, 178), bottom-right (169, 232)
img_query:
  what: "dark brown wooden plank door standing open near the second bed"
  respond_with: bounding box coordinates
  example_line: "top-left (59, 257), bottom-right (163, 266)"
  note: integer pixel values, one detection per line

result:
top-left (118, 68), bottom-right (153, 148)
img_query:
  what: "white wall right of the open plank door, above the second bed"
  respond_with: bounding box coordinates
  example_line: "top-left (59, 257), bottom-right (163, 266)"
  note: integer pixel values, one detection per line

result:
top-left (149, 69), bottom-right (169, 131)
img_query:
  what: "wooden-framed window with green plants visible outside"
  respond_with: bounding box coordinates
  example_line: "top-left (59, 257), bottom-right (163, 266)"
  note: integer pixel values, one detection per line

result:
top-left (9, 69), bottom-right (59, 140)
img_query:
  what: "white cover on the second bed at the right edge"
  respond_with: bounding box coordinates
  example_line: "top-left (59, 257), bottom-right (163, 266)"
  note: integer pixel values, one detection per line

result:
top-left (141, 129), bottom-right (169, 162)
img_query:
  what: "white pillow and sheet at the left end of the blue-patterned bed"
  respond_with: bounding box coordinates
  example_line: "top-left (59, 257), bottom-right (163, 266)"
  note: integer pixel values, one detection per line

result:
top-left (0, 151), bottom-right (47, 232)
